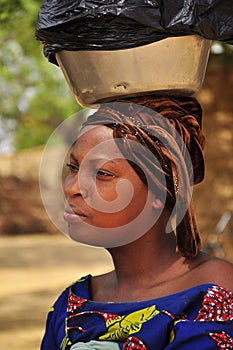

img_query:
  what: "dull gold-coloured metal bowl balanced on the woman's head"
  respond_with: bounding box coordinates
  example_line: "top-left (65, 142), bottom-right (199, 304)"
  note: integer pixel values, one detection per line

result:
top-left (56, 35), bottom-right (211, 106)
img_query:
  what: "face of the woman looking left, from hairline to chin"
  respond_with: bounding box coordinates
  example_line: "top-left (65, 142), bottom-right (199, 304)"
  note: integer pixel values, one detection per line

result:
top-left (64, 126), bottom-right (159, 246)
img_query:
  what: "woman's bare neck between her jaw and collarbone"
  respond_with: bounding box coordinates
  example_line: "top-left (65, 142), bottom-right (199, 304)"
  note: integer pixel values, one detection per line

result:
top-left (109, 233), bottom-right (180, 287)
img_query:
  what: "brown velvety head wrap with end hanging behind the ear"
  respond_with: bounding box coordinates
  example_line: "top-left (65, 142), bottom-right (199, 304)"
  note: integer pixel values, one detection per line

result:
top-left (84, 96), bottom-right (204, 256)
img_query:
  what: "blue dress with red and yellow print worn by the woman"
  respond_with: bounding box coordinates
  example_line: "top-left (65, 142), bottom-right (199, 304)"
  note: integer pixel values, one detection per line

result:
top-left (41, 275), bottom-right (233, 350)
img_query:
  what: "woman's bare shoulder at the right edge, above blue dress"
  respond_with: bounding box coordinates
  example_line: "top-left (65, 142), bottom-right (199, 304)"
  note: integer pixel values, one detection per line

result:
top-left (196, 257), bottom-right (233, 292)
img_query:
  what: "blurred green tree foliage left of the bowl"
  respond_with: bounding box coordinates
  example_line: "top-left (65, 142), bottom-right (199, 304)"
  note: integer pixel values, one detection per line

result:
top-left (0, 0), bottom-right (79, 150)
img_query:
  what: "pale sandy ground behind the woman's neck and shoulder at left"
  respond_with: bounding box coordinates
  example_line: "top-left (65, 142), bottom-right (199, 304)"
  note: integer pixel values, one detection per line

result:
top-left (0, 234), bottom-right (111, 350)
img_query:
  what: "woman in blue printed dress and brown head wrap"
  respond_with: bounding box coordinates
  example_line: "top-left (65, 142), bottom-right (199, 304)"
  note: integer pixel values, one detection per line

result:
top-left (42, 97), bottom-right (233, 350)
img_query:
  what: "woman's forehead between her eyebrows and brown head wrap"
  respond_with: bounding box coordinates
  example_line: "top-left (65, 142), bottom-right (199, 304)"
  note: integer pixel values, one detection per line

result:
top-left (73, 125), bottom-right (122, 159)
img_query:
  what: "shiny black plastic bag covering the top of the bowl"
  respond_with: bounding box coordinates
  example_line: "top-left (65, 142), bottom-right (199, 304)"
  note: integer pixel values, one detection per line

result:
top-left (36, 0), bottom-right (233, 63)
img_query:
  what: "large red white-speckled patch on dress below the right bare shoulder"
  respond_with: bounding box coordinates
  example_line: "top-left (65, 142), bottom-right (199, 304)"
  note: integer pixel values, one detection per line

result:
top-left (195, 286), bottom-right (233, 322)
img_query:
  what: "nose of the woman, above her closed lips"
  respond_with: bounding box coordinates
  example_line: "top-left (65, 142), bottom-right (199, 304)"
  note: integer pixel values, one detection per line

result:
top-left (64, 174), bottom-right (88, 198)
